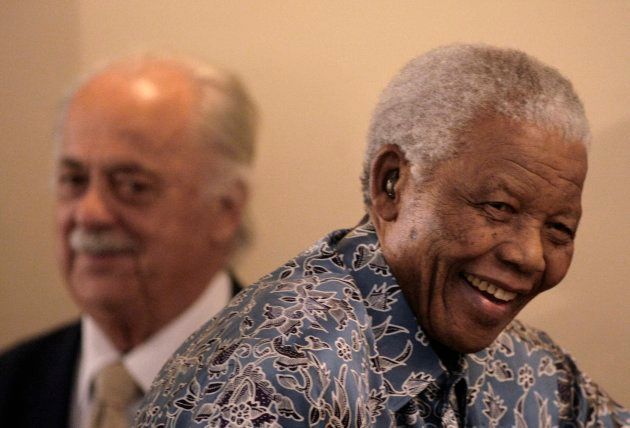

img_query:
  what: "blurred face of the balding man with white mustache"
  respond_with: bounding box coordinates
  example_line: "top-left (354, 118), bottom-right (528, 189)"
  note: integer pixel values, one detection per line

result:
top-left (56, 67), bottom-right (233, 317)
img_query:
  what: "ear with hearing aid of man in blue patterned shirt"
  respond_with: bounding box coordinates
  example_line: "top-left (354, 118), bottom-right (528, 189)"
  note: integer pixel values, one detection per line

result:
top-left (370, 144), bottom-right (409, 221)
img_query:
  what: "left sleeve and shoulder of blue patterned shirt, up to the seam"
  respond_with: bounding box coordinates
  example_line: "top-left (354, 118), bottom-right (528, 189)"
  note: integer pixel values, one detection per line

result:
top-left (139, 241), bottom-right (373, 426)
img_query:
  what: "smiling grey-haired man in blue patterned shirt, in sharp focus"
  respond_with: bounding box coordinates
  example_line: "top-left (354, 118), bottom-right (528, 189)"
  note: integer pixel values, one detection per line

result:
top-left (138, 45), bottom-right (630, 427)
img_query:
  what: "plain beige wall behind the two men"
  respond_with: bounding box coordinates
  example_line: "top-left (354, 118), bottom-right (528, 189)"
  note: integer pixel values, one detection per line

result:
top-left (0, 0), bottom-right (630, 404)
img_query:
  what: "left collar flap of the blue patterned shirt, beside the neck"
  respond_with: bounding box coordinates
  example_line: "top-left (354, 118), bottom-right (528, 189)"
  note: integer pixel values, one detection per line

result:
top-left (331, 218), bottom-right (462, 412)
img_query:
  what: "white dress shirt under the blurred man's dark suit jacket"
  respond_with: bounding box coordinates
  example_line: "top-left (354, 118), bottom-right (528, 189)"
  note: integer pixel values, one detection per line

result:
top-left (70, 272), bottom-right (232, 428)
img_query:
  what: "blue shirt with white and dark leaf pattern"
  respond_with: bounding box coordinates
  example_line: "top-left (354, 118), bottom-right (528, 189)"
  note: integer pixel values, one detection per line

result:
top-left (137, 223), bottom-right (630, 427)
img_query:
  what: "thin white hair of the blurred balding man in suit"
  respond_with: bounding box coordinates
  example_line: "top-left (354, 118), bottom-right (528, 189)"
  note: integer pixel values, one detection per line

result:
top-left (55, 53), bottom-right (258, 254)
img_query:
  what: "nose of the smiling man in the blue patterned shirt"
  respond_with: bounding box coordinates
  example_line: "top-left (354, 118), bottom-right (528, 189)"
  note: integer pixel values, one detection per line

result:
top-left (498, 226), bottom-right (545, 273)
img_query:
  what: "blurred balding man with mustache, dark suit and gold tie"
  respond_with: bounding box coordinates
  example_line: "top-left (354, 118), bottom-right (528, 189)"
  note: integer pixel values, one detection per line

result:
top-left (0, 56), bottom-right (255, 428)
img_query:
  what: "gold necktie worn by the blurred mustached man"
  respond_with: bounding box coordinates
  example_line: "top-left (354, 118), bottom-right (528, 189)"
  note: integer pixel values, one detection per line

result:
top-left (90, 361), bottom-right (141, 428)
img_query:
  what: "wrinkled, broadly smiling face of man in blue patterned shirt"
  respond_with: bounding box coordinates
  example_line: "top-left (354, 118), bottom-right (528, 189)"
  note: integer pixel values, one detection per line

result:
top-left (382, 120), bottom-right (587, 352)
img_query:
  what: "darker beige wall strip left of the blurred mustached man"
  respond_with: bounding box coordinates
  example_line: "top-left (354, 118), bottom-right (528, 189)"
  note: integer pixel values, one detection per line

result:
top-left (0, 0), bottom-right (79, 346)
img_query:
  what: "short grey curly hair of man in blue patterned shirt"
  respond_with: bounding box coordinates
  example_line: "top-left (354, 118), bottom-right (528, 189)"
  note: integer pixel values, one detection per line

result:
top-left (361, 44), bottom-right (590, 206)
